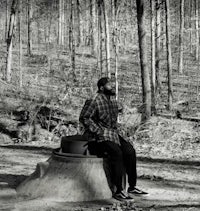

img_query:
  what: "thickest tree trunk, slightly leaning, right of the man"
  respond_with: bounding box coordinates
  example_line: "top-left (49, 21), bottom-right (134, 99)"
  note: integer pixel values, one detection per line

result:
top-left (136, 0), bottom-right (151, 121)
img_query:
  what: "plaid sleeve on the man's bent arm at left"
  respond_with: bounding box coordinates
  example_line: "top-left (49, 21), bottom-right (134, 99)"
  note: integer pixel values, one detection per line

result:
top-left (79, 100), bottom-right (102, 135)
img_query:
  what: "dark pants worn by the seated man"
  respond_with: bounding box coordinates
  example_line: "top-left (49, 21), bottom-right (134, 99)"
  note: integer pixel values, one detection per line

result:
top-left (88, 137), bottom-right (137, 191)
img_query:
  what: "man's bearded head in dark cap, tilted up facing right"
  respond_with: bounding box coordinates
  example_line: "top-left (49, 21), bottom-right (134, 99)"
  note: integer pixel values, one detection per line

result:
top-left (97, 77), bottom-right (115, 96)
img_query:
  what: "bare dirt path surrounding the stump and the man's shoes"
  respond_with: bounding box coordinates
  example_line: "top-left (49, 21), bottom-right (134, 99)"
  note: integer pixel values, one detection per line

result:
top-left (0, 147), bottom-right (200, 211)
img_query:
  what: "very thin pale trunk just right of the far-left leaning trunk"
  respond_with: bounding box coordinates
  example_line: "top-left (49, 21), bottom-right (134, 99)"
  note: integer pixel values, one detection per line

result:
top-left (18, 0), bottom-right (23, 88)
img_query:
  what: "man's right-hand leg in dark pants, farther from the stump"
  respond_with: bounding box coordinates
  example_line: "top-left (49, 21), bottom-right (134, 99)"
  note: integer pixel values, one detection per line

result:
top-left (120, 136), bottom-right (137, 188)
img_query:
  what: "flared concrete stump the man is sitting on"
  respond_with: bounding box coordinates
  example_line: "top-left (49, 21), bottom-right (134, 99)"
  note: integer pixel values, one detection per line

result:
top-left (17, 149), bottom-right (112, 202)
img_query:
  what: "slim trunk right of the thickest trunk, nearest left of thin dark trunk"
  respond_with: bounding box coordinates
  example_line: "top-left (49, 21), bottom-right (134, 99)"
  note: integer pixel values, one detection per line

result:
top-left (156, 0), bottom-right (161, 95)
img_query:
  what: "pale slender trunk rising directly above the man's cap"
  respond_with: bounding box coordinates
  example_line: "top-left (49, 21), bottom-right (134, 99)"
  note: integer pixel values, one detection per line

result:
top-left (102, 0), bottom-right (111, 78)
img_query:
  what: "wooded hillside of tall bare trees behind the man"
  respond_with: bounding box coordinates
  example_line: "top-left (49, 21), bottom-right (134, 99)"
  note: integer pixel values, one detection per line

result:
top-left (0, 0), bottom-right (200, 143)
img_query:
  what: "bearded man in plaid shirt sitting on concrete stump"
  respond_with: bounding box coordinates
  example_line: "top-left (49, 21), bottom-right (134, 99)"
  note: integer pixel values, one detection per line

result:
top-left (79, 77), bottom-right (146, 200)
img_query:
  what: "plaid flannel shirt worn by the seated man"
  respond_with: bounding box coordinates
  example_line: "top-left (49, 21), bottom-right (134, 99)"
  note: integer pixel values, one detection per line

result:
top-left (79, 93), bottom-right (120, 144)
